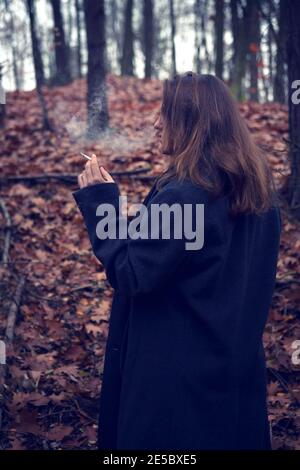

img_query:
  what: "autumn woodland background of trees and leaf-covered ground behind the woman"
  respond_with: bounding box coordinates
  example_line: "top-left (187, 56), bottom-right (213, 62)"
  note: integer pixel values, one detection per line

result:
top-left (0, 0), bottom-right (300, 450)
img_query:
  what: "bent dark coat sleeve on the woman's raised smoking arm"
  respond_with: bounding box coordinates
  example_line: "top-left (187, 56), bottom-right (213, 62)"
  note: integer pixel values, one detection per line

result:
top-left (73, 183), bottom-right (200, 295)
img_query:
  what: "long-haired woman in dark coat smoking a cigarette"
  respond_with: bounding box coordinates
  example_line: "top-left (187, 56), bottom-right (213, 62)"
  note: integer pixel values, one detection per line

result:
top-left (73, 72), bottom-right (281, 450)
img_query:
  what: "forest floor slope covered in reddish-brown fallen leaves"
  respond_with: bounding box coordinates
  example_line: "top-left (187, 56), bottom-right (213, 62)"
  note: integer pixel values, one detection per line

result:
top-left (0, 75), bottom-right (300, 450)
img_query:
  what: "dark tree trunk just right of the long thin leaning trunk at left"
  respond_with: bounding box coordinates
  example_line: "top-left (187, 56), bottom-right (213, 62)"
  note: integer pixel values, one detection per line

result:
top-left (51, 0), bottom-right (71, 85)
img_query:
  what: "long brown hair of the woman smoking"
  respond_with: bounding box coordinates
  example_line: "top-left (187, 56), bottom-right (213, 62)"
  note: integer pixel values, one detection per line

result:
top-left (157, 72), bottom-right (276, 215)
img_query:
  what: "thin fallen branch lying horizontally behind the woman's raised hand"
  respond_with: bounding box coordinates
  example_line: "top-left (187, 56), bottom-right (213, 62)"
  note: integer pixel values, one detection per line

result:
top-left (0, 168), bottom-right (150, 184)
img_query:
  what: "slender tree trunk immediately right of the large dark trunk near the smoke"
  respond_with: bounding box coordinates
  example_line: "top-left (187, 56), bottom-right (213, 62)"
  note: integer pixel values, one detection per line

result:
top-left (121, 0), bottom-right (134, 76)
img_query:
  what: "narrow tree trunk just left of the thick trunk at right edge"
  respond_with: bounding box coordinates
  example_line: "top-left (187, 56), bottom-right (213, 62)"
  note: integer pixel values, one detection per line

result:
top-left (274, 0), bottom-right (287, 103)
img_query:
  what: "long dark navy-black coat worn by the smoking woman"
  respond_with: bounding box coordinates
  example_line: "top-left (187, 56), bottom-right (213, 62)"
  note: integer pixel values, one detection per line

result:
top-left (73, 180), bottom-right (281, 450)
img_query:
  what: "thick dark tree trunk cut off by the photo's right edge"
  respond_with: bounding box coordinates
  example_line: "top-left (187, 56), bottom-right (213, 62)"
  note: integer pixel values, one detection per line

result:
top-left (285, 0), bottom-right (300, 220)
